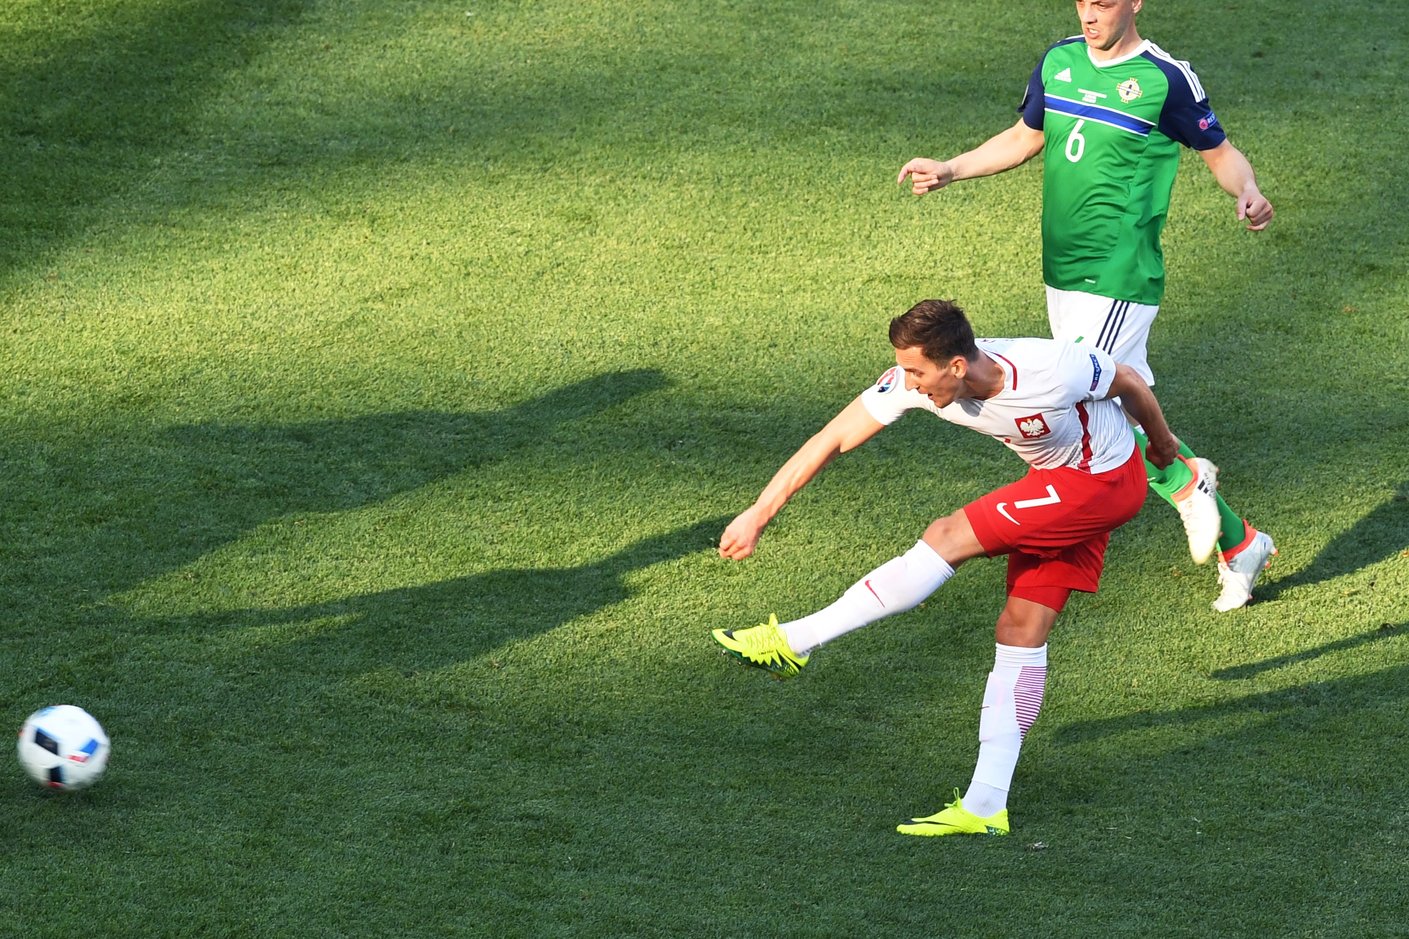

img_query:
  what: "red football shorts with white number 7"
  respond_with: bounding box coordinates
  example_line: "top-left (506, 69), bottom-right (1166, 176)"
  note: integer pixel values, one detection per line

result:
top-left (964, 447), bottom-right (1146, 612)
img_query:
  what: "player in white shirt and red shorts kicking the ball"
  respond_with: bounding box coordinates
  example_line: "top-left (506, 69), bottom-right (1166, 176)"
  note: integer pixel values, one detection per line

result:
top-left (713, 300), bottom-right (1179, 835)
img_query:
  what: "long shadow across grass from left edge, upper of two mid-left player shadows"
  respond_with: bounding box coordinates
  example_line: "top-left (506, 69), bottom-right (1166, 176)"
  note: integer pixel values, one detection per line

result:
top-left (0, 369), bottom-right (666, 623)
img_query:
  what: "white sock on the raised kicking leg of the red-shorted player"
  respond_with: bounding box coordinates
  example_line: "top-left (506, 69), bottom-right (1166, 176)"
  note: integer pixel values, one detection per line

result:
top-left (782, 541), bottom-right (954, 656)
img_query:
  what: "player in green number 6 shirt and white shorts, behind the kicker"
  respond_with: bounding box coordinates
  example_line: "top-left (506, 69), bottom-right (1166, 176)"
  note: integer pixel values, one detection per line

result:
top-left (898, 0), bottom-right (1277, 612)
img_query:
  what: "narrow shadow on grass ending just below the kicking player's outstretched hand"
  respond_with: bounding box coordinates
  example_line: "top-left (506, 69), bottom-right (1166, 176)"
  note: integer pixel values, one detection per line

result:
top-left (163, 517), bottom-right (728, 674)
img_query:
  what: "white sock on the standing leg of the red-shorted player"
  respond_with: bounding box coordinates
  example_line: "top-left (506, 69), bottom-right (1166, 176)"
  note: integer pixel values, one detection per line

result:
top-left (962, 643), bottom-right (1047, 818)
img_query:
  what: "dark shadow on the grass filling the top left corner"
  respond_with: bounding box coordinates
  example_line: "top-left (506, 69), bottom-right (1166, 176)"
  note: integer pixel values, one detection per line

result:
top-left (0, 0), bottom-right (311, 279)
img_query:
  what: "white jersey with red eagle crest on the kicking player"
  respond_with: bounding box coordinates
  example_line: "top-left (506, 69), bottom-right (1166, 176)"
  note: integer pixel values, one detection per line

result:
top-left (861, 338), bottom-right (1136, 472)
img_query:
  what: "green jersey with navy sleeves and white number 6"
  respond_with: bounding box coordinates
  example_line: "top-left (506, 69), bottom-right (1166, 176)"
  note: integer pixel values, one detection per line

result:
top-left (1019, 37), bottom-right (1224, 305)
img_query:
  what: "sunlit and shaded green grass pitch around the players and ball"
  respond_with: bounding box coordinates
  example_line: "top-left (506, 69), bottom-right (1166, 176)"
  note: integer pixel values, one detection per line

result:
top-left (0, 0), bottom-right (1409, 939)
